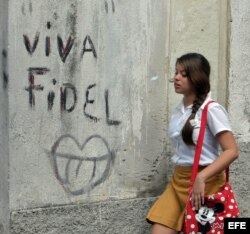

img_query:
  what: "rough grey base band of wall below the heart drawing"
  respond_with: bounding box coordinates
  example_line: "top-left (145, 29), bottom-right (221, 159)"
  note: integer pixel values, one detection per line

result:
top-left (11, 198), bottom-right (152, 234)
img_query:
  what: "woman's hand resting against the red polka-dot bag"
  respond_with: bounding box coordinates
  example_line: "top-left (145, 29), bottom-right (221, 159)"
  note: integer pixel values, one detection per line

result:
top-left (191, 174), bottom-right (205, 210)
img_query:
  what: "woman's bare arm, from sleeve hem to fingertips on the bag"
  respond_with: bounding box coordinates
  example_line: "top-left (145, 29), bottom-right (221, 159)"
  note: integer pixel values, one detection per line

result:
top-left (192, 131), bottom-right (239, 209)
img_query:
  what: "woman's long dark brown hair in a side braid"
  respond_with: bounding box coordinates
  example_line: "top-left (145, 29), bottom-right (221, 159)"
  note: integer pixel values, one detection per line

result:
top-left (176, 53), bottom-right (210, 145)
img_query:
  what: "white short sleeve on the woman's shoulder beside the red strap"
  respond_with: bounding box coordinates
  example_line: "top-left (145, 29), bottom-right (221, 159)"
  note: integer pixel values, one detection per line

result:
top-left (207, 103), bottom-right (232, 136)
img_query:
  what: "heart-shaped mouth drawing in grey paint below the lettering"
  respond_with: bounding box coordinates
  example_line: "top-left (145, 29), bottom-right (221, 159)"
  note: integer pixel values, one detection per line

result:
top-left (51, 134), bottom-right (114, 196)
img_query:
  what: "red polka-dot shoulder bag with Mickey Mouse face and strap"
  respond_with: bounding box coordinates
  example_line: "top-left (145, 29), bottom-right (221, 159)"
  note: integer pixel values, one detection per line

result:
top-left (183, 101), bottom-right (239, 234)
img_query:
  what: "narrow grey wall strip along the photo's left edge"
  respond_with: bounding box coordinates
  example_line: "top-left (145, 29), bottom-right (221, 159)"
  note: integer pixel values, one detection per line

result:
top-left (0, 0), bottom-right (9, 233)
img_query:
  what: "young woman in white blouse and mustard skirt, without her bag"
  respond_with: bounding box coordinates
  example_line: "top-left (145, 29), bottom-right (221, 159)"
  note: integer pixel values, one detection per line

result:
top-left (147, 53), bottom-right (238, 234)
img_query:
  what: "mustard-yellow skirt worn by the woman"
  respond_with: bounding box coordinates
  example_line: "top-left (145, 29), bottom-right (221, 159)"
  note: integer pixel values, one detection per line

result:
top-left (147, 166), bottom-right (226, 231)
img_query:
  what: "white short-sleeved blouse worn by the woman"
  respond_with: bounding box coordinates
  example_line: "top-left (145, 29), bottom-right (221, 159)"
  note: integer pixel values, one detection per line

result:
top-left (168, 97), bottom-right (231, 166)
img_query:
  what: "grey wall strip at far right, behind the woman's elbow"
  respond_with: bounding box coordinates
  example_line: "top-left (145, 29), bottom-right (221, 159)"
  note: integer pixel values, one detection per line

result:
top-left (228, 0), bottom-right (250, 217)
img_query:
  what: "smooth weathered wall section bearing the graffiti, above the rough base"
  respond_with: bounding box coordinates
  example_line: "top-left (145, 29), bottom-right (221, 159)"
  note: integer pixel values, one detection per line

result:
top-left (9, 0), bottom-right (167, 210)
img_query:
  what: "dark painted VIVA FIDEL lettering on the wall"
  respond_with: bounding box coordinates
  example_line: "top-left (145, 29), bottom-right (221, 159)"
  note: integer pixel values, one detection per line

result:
top-left (23, 18), bottom-right (120, 125)
